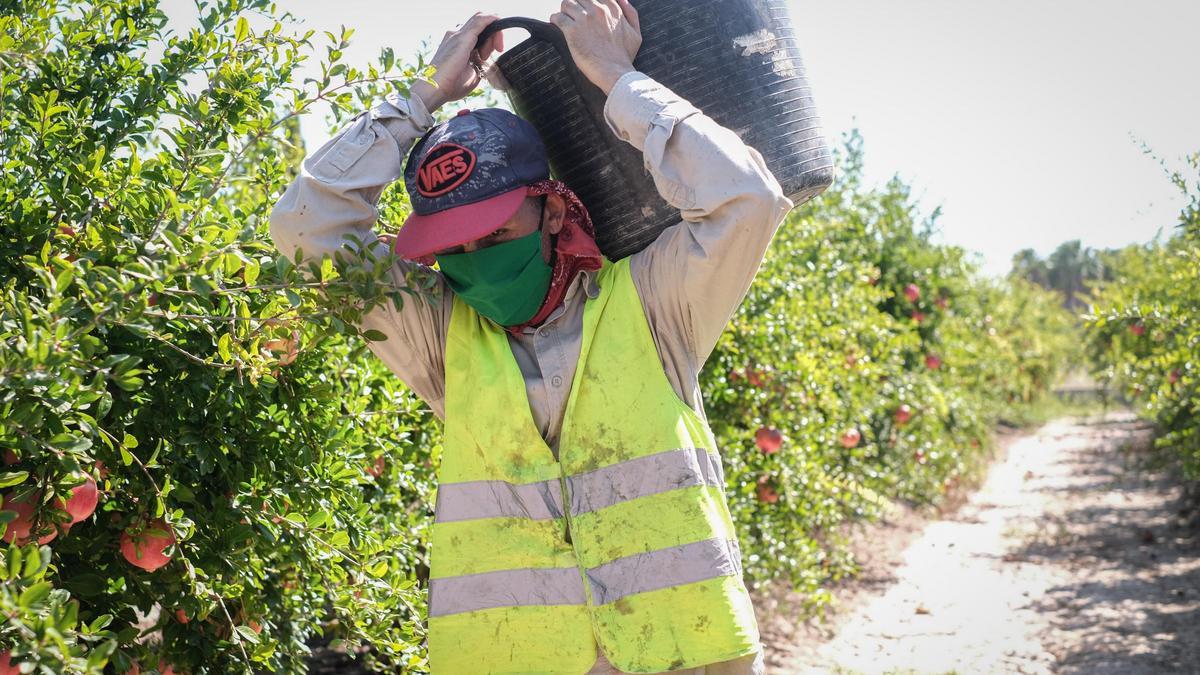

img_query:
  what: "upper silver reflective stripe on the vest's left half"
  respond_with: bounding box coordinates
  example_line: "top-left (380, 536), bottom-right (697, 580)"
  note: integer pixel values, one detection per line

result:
top-left (434, 479), bottom-right (563, 522)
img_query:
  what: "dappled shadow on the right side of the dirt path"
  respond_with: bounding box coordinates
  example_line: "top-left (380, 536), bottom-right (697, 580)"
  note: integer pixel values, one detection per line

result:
top-left (1009, 424), bottom-right (1200, 675)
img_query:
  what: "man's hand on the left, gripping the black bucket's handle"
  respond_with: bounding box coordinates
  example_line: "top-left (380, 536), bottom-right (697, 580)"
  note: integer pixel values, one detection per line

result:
top-left (412, 12), bottom-right (504, 113)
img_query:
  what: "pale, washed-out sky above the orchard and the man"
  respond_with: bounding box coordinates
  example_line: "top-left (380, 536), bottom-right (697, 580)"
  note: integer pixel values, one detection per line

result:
top-left (163, 0), bottom-right (1200, 274)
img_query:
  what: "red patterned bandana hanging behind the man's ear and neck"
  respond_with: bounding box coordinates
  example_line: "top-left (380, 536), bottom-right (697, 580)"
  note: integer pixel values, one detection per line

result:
top-left (506, 180), bottom-right (604, 333)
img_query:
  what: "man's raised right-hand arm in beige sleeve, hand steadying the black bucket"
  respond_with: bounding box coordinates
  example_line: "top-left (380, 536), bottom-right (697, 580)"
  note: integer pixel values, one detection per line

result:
top-left (551, 0), bottom-right (793, 374)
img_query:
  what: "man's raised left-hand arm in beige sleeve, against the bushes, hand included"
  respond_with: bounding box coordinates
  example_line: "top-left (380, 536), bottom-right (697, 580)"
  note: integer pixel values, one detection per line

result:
top-left (270, 14), bottom-right (500, 417)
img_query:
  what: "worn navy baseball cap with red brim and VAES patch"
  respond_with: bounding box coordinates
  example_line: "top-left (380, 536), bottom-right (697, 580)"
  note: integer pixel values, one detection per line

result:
top-left (395, 108), bottom-right (550, 259)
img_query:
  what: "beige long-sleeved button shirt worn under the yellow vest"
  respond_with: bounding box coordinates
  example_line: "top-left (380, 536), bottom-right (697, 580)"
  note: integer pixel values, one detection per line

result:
top-left (270, 72), bottom-right (792, 673)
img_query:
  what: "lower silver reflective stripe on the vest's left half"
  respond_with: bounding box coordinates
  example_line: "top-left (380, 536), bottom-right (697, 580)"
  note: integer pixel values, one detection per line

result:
top-left (430, 567), bottom-right (587, 616)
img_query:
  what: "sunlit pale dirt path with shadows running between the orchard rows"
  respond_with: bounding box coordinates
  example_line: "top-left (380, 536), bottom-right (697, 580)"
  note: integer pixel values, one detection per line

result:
top-left (764, 416), bottom-right (1200, 675)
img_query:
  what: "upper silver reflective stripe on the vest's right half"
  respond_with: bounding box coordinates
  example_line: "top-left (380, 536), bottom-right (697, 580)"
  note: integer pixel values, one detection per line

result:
top-left (566, 448), bottom-right (725, 513)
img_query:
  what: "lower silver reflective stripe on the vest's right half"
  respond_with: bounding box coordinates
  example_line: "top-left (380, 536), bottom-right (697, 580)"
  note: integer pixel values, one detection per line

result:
top-left (587, 538), bottom-right (742, 604)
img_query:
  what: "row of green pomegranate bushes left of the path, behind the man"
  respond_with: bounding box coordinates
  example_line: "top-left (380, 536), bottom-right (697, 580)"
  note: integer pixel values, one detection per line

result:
top-left (0, 0), bottom-right (1075, 674)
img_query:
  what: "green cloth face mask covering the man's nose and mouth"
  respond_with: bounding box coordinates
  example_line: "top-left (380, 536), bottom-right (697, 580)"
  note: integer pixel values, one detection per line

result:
top-left (434, 228), bottom-right (552, 325)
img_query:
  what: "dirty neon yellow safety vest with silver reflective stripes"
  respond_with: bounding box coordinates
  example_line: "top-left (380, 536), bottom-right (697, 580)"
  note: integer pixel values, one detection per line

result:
top-left (428, 258), bottom-right (758, 675)
